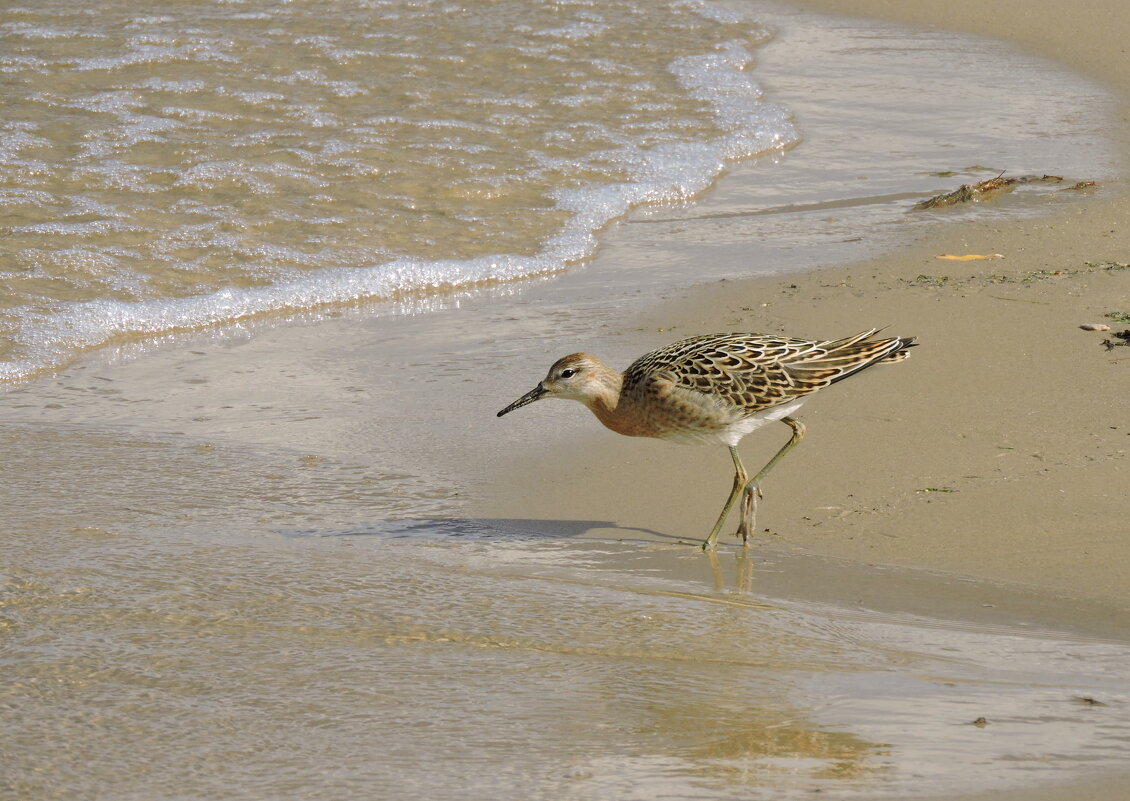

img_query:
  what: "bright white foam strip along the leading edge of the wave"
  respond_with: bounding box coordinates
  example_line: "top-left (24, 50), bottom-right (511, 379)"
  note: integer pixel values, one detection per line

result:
top-left (0, 17), bottom-right (797, 380)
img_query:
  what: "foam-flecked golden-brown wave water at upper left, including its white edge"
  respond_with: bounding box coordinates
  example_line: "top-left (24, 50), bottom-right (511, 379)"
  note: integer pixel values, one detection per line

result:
top-left (0, 0), bottom-right (796, 378)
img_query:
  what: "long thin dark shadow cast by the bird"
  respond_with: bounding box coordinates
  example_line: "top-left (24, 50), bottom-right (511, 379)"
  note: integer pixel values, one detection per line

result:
top-left (278, 517), bottom-right (689, 542)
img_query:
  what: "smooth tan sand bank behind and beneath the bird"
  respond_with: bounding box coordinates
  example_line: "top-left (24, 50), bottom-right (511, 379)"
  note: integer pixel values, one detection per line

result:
top-left (492, 201), bottom-right (1130, 607)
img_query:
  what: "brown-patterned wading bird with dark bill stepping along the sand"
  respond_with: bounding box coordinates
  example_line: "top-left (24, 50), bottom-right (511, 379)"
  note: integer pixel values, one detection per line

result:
top-left (497, 329), bottom-right (916, 550)
